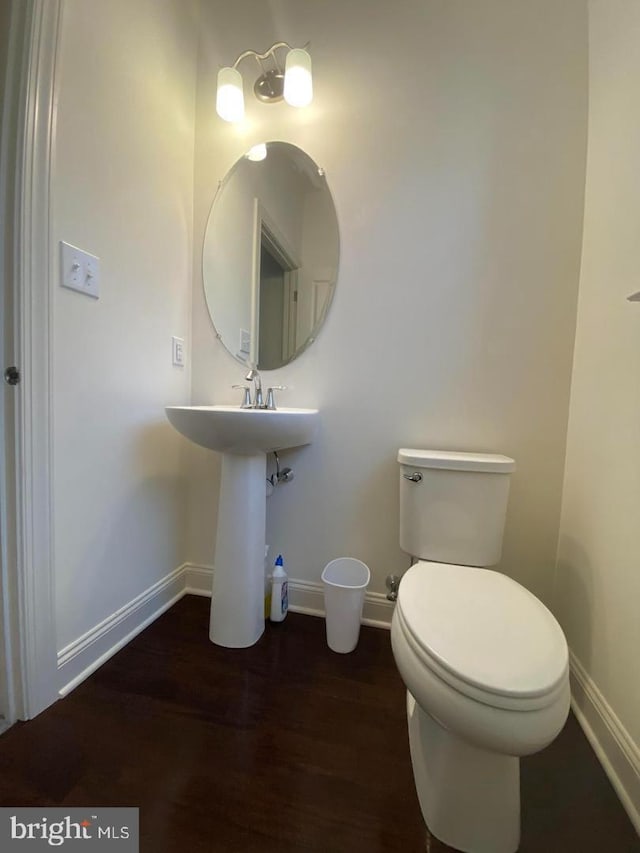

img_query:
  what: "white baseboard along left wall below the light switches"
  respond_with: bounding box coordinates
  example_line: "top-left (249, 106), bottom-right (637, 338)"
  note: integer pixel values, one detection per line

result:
top-left (58, 565), bottom-right (187, 696)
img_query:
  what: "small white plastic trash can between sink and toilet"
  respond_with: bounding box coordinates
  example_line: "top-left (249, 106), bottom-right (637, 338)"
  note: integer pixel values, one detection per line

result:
top-left (322, 557), bottom-right (371, 654)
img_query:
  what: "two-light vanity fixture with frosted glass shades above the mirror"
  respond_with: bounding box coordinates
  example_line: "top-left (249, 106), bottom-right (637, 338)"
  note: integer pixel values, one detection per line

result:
top-left (216, 41), bottom-right (313, 122)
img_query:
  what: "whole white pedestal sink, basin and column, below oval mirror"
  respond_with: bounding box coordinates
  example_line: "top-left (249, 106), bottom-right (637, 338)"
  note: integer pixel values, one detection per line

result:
top-left (165, 406), bottom-right (320, 648)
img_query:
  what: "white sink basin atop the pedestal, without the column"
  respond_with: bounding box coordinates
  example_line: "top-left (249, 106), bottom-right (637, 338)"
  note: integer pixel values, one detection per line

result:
top-left (165, 406), bottom-right (320, 456)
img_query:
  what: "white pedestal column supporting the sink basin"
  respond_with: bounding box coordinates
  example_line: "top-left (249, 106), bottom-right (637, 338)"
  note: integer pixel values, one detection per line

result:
top-left (209, 453), bottom-right (267, 649)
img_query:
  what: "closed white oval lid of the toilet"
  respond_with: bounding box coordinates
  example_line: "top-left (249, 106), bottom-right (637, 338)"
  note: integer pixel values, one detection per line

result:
top-left (397, 561), bottom-right (568, 698)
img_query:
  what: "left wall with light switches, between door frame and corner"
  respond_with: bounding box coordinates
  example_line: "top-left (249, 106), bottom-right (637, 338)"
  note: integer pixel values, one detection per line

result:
top-left (52, 0), bottom-right (197, 649)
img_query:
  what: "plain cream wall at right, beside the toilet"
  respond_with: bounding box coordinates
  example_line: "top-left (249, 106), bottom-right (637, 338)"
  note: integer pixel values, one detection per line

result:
top-left (556, 0), bottom-right (640, 830)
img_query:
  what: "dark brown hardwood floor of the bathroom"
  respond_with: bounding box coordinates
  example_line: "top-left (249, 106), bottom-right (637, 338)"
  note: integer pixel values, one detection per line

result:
top-left (0, 596), bottom-right (640, 853)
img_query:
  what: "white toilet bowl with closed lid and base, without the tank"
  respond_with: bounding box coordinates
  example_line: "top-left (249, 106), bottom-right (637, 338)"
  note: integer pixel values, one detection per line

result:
top-left (391, 561), bottom-right (570, 853)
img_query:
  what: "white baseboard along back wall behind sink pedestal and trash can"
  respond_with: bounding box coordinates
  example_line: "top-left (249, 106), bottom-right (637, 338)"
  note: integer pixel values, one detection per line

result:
top-left (186, 563), bottom-right (393, 629)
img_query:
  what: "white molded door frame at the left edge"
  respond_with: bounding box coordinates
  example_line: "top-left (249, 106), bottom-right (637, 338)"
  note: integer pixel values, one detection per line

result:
top-left (1, 0), bottom-right (63, 722)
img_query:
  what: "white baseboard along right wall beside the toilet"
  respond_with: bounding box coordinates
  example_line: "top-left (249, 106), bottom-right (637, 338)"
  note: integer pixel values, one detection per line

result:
top-left (571, 652), bottom-right (640, 834)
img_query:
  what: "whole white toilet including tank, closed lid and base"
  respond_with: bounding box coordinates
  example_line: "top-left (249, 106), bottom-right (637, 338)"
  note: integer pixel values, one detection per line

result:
top-left (391, 449), bottom-right (570, 853)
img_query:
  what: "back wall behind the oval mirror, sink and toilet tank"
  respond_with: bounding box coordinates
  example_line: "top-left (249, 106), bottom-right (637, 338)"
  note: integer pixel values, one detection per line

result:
top-left (188, 0), bottom-right (587, 600)
